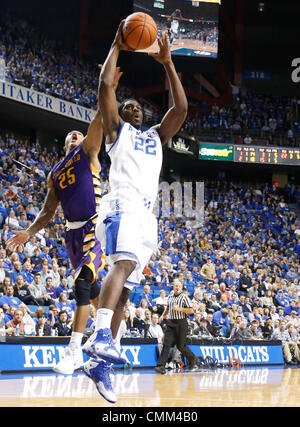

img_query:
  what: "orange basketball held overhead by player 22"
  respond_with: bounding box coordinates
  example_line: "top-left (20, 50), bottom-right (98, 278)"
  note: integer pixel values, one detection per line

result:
top-left (122, 12), bottom-right (157, 50)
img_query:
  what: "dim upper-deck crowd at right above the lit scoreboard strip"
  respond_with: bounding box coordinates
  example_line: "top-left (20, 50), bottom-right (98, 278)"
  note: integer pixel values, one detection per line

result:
top-left (184, 89), bottom-right (300, 147)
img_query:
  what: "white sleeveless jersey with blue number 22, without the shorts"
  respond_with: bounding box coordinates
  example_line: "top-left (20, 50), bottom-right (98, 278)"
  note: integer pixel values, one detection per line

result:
top-left (106, 122), bottom-right (162, 211)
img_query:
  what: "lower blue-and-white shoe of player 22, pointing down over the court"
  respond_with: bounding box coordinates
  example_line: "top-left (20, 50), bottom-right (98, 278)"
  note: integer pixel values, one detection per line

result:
top-left (83, 359), bottom-right (117, 403)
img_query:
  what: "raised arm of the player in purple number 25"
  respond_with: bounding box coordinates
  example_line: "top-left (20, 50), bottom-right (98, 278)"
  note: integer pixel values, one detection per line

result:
top-left (82, 64), bottom-right (123, 160)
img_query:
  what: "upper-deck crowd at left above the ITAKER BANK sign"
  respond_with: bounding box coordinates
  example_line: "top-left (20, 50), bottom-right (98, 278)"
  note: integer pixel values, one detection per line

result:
top-left (0, 12), bottom-right (159, 123)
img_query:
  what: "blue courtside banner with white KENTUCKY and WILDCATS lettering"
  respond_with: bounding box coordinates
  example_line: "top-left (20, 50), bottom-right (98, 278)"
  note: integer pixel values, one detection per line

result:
top-left (0, 337), bottom-right (284, 372)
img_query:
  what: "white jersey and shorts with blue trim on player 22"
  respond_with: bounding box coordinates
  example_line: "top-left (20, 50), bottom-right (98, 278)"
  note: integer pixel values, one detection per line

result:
top-left (96, 120), bottom-right (162, 289)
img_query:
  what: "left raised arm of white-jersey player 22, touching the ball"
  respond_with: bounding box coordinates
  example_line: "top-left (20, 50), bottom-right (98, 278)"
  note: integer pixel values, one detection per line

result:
top-left (99, 20), bottom-right (128, 144)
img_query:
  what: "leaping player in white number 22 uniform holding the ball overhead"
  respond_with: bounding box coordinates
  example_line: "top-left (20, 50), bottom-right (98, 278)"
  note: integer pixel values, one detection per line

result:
top-left (83, 21), bottom-right (187, 400)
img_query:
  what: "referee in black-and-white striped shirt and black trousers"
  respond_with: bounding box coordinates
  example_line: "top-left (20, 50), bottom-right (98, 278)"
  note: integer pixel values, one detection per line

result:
top-left (155, 279), bottom-right (198, 374)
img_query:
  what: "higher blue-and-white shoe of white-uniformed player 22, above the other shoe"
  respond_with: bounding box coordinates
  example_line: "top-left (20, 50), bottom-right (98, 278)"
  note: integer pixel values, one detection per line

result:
top-left (82, 328), bottom-right (127, 365)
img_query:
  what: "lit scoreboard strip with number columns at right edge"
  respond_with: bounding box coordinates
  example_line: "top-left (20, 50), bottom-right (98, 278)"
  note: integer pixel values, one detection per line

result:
top-left (234, 146), bottom-right (300, 166)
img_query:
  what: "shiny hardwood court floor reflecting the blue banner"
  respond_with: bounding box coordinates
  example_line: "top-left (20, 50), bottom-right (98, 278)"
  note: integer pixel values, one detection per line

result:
top-left (0, 367), bottom-right (300, 408)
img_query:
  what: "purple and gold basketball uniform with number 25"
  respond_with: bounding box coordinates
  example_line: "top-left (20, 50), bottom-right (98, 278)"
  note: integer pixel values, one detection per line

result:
top-left (51, 144), bottom-right (105, 281)
